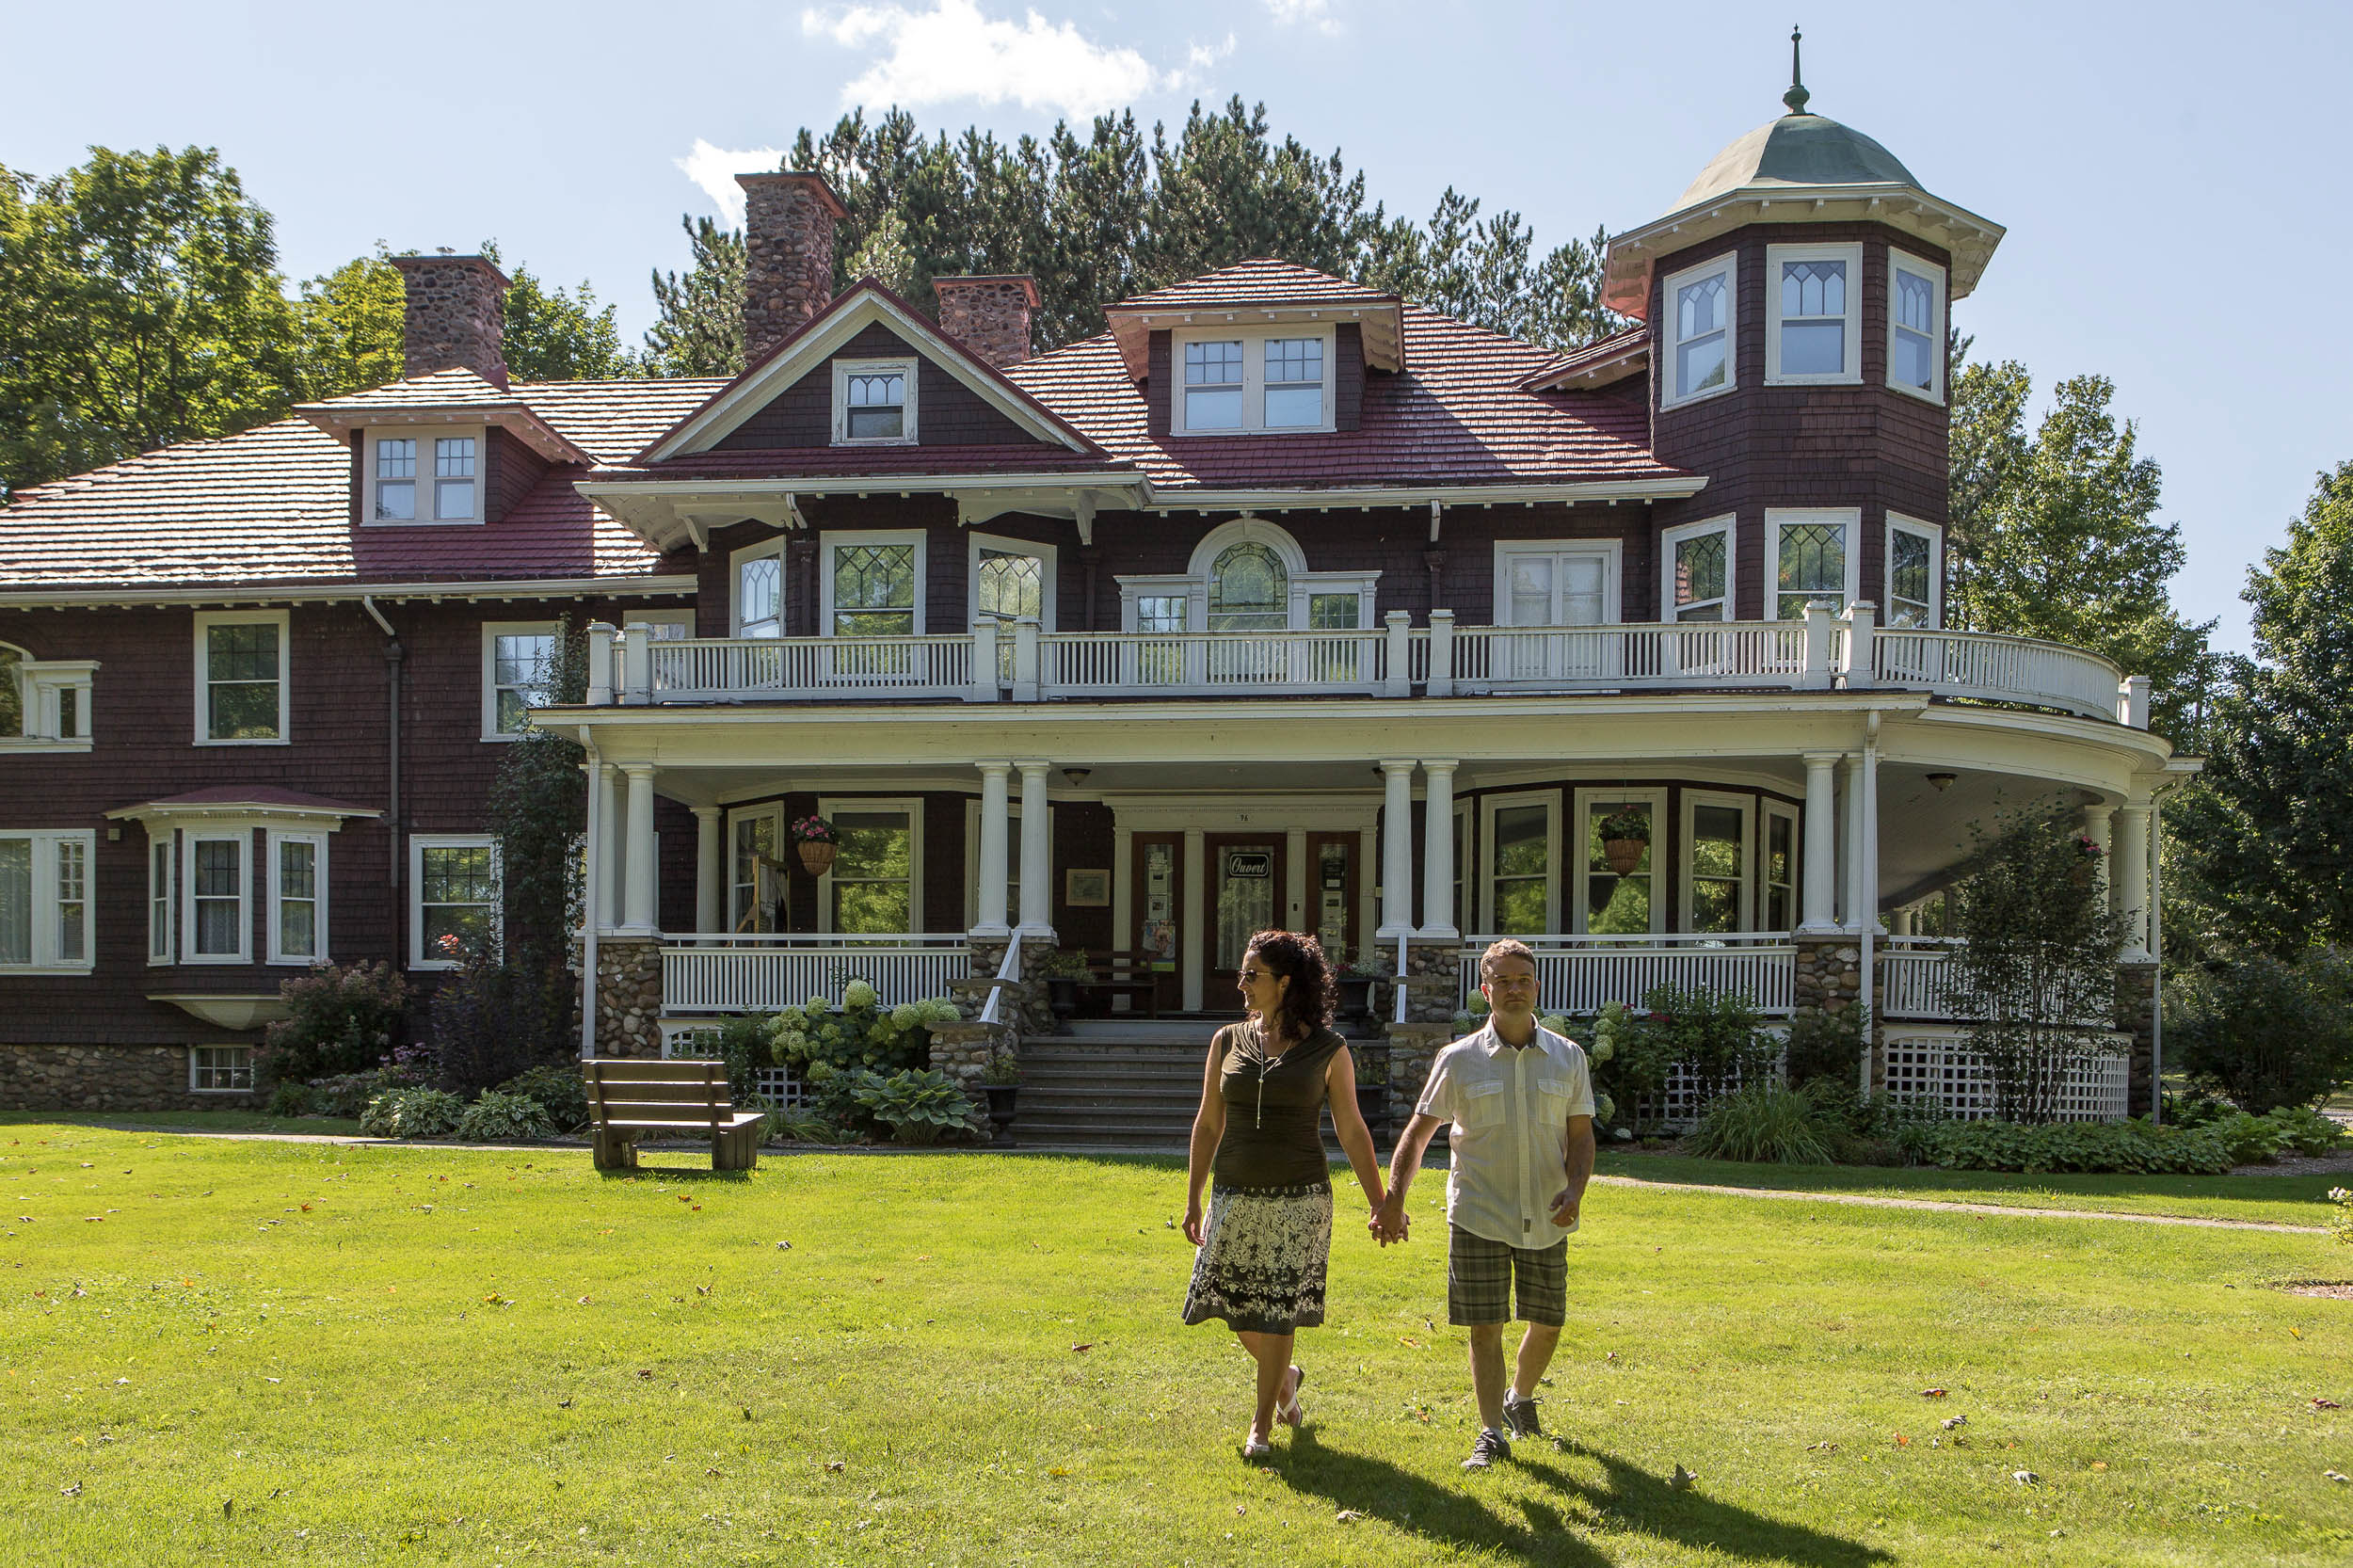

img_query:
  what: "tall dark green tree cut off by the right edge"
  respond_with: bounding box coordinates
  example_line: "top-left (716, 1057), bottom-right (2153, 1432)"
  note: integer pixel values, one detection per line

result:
top-left (2165, 461), bottom-right (2353, 958)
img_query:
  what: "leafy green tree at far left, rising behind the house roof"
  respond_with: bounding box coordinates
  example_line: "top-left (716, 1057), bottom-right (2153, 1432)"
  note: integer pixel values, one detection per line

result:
top-left (0, 146), bottom-right (296, 492)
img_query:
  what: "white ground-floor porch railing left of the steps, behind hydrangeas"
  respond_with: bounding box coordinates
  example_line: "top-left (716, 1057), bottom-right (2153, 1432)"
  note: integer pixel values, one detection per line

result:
top-left (662, 933), bottom-right (972, 1015)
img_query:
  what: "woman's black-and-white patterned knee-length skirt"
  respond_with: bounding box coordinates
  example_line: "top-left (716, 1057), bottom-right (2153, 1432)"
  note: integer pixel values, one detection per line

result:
top-left (1184, 1182), bottom-right (1332, 1335)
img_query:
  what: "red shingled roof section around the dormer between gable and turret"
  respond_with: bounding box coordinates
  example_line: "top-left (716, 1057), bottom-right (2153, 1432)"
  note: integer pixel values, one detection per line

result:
top-left (1007, 306), bottom-right (1680, 489)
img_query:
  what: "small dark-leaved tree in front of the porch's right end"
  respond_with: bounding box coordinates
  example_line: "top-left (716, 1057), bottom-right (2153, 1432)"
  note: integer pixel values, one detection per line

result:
top-left (1948, 806), bottom-right (2125, 1121)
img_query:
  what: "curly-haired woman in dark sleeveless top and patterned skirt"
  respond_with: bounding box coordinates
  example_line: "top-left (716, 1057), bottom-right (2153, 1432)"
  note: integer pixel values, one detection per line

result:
top-left (1184, 930), bottom-right (1386, 1460)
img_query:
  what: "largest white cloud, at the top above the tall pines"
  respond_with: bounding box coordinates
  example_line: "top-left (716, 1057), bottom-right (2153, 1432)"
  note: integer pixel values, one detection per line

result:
top-left (800, 0), bottom-right (1176, 120)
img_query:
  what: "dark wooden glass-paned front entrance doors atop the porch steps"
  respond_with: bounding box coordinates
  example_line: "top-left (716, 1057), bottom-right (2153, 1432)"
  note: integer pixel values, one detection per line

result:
top-left (1129, 831), bottom-right (1363, 1013)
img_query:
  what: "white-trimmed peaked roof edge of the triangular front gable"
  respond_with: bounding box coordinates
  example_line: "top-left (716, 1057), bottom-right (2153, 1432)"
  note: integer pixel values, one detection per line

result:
top-left (638, 278), bottom-right (1095, 464)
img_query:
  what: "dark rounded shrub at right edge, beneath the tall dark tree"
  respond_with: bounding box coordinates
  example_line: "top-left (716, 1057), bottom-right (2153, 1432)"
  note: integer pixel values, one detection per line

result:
top-left (2165, 952), bottom-right (2353, 1116)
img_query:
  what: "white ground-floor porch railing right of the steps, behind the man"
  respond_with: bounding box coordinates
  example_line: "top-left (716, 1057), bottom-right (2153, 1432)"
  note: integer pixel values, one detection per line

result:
top-left (1462, 933), bottom-right (1798, 1017)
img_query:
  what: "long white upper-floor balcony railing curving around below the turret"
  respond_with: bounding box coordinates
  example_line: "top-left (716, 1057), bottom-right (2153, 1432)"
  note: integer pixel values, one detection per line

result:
top-left (588, 605), bottom-right (2149, 728)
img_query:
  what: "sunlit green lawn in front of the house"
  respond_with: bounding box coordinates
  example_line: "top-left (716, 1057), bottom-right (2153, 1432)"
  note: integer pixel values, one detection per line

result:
top-left (0, 1123), bottom-right (2353, 1568)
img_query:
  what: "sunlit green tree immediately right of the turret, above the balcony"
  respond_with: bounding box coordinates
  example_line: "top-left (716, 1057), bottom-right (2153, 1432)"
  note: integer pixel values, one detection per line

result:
top-left (1944, 339), bottom-right (2215, 737)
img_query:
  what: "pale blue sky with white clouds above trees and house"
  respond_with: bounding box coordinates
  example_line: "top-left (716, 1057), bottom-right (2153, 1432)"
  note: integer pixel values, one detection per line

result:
top-left (0, 0), bottom-right (2353, 648)
